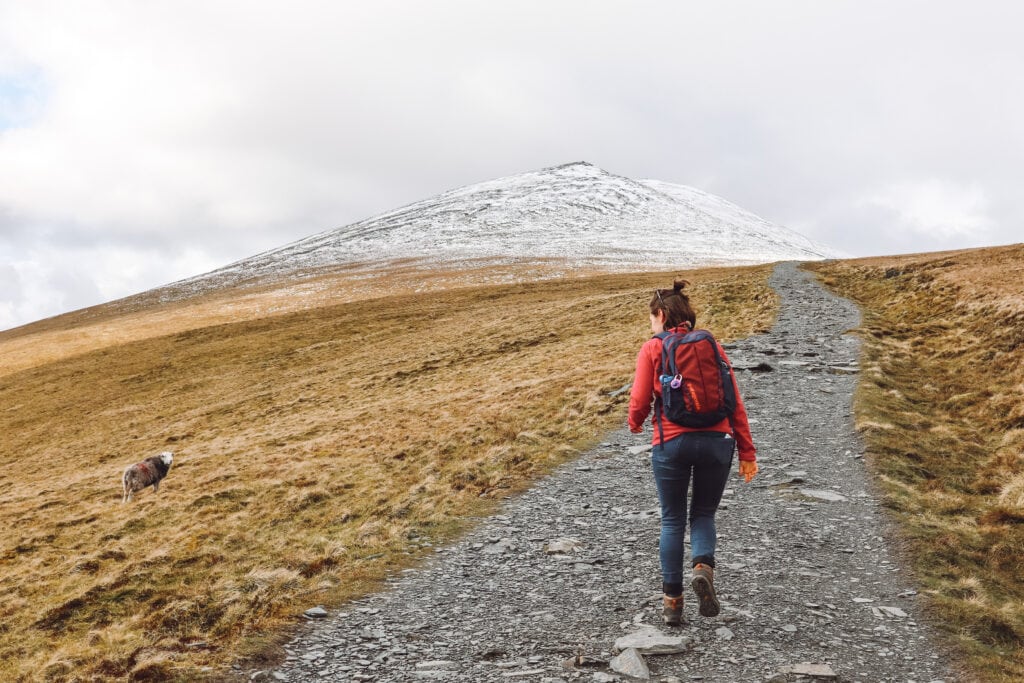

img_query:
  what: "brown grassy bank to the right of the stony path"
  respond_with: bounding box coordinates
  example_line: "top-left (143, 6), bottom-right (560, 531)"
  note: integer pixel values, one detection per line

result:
top-left (809, 245), bottom-right (1024, 683)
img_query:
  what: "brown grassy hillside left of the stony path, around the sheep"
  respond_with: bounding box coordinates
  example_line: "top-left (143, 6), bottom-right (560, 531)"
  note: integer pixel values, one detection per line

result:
top-left (0, 266), bottom-right (776, 681)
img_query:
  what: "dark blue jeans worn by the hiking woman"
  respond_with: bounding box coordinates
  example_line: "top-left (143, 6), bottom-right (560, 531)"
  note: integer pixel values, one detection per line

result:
top-left (650, 432), bottom-right (736, 584)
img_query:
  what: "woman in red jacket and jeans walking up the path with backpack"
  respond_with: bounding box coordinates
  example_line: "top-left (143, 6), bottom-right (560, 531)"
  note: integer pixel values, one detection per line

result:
top-left (629, 280), bottom-right (758, 626)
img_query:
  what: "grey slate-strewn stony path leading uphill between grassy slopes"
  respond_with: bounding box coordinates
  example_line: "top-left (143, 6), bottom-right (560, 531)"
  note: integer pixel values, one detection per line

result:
top-left (239, 264), bottom-right (953, 683)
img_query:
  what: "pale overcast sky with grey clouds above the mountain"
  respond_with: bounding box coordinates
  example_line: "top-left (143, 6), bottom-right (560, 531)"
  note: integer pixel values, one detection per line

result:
top-left (0, 0), bottom-right (1024, 329)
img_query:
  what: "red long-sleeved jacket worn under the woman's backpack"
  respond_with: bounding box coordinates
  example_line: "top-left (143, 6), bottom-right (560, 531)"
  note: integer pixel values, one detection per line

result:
top-left (630, 328), bottom-right (757, 461)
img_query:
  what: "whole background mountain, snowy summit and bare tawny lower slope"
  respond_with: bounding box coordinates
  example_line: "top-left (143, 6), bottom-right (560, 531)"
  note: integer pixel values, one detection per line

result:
top-left (0, 163), bottom-right (838, 376)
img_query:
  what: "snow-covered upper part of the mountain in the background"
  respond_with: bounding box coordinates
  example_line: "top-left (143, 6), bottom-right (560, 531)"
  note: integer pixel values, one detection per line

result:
top-left (174, 162), bottom-right (838, 291)
